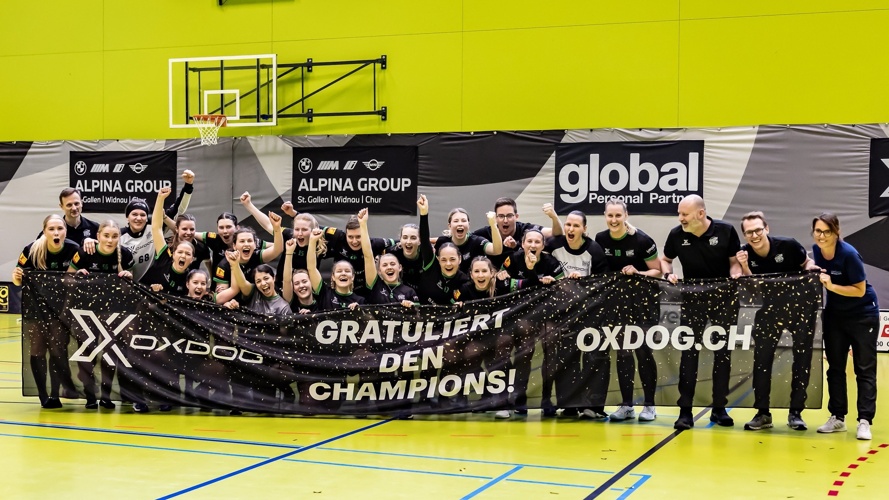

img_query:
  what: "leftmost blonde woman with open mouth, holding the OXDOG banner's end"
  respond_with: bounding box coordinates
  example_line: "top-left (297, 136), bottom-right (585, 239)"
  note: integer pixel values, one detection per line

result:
top-left (12, 214), bottom-right (80, 408)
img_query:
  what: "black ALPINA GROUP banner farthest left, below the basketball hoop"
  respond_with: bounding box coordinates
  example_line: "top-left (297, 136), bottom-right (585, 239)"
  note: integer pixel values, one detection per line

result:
top-left (68, 151), bottom-right (177, 213)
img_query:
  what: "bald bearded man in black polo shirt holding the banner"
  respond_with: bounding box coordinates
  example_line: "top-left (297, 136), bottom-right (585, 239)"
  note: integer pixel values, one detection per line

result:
top-left (664, 194), bottom-right (741, 430)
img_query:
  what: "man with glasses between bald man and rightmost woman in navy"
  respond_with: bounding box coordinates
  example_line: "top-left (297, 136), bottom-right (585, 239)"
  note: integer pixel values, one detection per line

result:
top-left (737, 212), bottom-right (818, 431)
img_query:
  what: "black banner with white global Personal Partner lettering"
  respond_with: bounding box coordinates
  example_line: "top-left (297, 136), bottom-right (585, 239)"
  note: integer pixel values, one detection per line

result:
top-left (555, 141), bottom-right (704, 215)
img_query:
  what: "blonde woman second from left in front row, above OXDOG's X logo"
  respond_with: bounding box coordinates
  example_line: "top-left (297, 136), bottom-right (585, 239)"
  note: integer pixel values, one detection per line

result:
top-left (68, 219), bottom-right (136, 410)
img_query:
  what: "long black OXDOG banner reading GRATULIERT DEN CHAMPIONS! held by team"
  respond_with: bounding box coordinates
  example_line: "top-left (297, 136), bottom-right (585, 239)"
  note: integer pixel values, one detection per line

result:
top-left (22, 272), bottom-right (821, 414)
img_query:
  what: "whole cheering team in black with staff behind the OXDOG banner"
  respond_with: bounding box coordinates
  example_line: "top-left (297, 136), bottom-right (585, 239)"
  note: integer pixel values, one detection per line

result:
top-left (13, 171), bottom-right (879, 439)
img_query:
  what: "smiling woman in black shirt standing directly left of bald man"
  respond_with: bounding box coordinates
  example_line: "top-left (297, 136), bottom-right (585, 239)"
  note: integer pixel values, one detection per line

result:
top-left (595, 198), bottom-right (661, 422)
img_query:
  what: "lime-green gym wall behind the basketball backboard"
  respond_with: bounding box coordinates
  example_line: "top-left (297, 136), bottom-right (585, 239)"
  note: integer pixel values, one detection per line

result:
top-left (0, 0), bottom-right (889, 141)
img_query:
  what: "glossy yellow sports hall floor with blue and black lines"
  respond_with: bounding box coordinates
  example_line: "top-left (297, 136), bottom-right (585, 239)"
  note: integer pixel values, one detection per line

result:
top-left (0, 315), bottom-right (889, 500)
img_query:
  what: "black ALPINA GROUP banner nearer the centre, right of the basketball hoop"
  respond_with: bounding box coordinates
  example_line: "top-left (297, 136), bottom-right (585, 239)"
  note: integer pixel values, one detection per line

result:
top-left (292, 146), bottom-right (419, 215)
